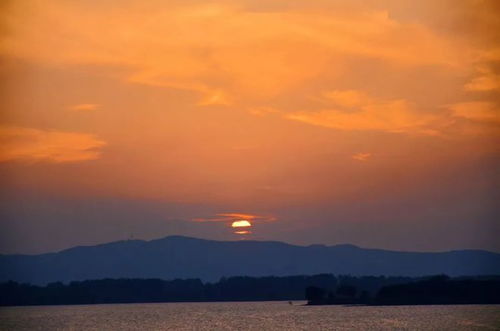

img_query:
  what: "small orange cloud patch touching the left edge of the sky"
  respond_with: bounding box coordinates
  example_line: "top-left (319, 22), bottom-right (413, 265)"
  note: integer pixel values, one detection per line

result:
top-left (0, 127), bottom-right (105, 163)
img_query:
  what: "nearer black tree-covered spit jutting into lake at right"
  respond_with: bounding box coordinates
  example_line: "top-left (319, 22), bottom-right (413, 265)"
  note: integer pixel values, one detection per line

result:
top-left (306, 275), bottom-right (500, 305)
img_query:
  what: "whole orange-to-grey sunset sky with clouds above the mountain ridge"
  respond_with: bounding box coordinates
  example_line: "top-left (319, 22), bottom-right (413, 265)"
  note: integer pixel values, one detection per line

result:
top-left (0, 0), bottom-right (500, 253)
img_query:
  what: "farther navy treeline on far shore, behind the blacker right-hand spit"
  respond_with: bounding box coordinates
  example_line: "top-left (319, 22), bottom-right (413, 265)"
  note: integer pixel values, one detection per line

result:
top-left (0, 274), bottom-right (412, 305)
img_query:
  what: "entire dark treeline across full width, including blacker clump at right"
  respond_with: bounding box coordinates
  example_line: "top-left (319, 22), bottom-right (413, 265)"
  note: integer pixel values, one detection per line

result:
top-left (0, 274), bottom-right (500, 306)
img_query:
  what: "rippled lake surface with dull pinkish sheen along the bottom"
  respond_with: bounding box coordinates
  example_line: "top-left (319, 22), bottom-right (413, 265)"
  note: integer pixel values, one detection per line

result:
top-left (0, 301), bottom-right (500, 331)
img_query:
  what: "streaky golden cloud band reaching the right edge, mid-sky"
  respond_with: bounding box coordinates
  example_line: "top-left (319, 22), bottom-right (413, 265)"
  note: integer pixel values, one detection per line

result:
top-left (285, 90), bottom-right (500, 136)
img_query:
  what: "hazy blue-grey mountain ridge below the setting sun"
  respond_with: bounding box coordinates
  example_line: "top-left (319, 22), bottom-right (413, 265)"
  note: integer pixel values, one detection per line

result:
top-left (0, 236), bottom-right (500, 284)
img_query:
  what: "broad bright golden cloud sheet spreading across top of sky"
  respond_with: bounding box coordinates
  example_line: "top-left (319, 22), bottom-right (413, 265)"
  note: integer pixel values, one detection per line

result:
top-left (2, 0), bottom-right (473, 105)
